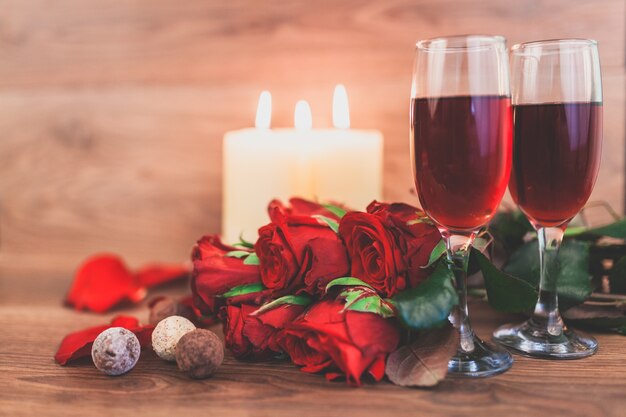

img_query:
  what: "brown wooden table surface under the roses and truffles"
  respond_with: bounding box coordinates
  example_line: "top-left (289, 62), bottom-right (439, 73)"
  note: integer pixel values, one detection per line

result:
top-left (0, 269), bottom-right (626, 417)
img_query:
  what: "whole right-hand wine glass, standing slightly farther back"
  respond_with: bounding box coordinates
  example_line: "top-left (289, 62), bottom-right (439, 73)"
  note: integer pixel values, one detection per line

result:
top-left (493, 39), bottom-right (602, 359)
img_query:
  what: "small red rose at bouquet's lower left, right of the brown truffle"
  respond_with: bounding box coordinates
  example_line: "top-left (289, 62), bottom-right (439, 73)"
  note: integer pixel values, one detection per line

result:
top-left (223, 304), bottom-right (306, 359)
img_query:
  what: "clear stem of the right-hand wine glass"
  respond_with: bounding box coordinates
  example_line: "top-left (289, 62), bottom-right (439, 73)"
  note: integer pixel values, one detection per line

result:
top-left (533, 227), bottom-right (563, 336)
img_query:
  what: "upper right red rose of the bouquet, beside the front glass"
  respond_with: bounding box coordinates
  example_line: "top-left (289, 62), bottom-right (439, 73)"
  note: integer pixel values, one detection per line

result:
top-left (339, 202), bottom-right (441, 297)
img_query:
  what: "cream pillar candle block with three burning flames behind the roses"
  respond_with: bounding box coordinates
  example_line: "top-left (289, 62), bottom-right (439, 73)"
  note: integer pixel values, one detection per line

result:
top-left (222, 87), bottom-right (383, 243)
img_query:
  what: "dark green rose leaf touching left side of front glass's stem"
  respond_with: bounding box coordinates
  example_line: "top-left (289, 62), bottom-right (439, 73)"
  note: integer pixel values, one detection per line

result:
top-left (393, 262), bottom-right (459, 330)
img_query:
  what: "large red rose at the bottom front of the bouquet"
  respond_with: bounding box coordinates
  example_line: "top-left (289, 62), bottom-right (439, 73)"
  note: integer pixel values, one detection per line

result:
top-left (278, 300), bottom-right (400, 384)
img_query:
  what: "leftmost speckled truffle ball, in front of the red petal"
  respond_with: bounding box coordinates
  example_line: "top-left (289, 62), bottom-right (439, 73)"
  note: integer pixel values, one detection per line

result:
top-left (91, 327), bottom-right (141, 375)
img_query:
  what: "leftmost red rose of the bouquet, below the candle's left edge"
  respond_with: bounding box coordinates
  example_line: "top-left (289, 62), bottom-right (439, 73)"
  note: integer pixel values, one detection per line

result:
top-left (191, 235), bottom-right (269, 315)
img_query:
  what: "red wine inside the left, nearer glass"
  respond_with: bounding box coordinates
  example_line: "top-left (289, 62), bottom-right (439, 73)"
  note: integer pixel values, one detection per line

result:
top-left (411, 96), bottom-right (511, 231)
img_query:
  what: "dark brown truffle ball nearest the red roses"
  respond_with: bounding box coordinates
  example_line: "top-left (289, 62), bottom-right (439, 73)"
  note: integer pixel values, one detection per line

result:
top-left (176, 329), bottom-right (224, 379)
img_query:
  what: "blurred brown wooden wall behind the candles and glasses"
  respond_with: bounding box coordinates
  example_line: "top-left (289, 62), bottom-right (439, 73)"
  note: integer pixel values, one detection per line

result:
top-left (0, 0), bottom-right (626, 278)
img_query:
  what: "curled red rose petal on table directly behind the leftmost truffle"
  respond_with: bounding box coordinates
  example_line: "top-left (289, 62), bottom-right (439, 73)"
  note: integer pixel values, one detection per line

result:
top-left (54, 316), bottom-right (154, 365)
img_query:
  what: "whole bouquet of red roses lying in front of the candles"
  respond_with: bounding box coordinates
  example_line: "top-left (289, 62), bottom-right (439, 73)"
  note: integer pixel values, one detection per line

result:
top-left (191, 198), bottom-right (444, 384)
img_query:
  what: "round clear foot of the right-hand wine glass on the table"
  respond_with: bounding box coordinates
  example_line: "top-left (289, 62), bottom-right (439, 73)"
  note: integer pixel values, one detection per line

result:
top-left (493, 319), bottom-right (598, 359)
